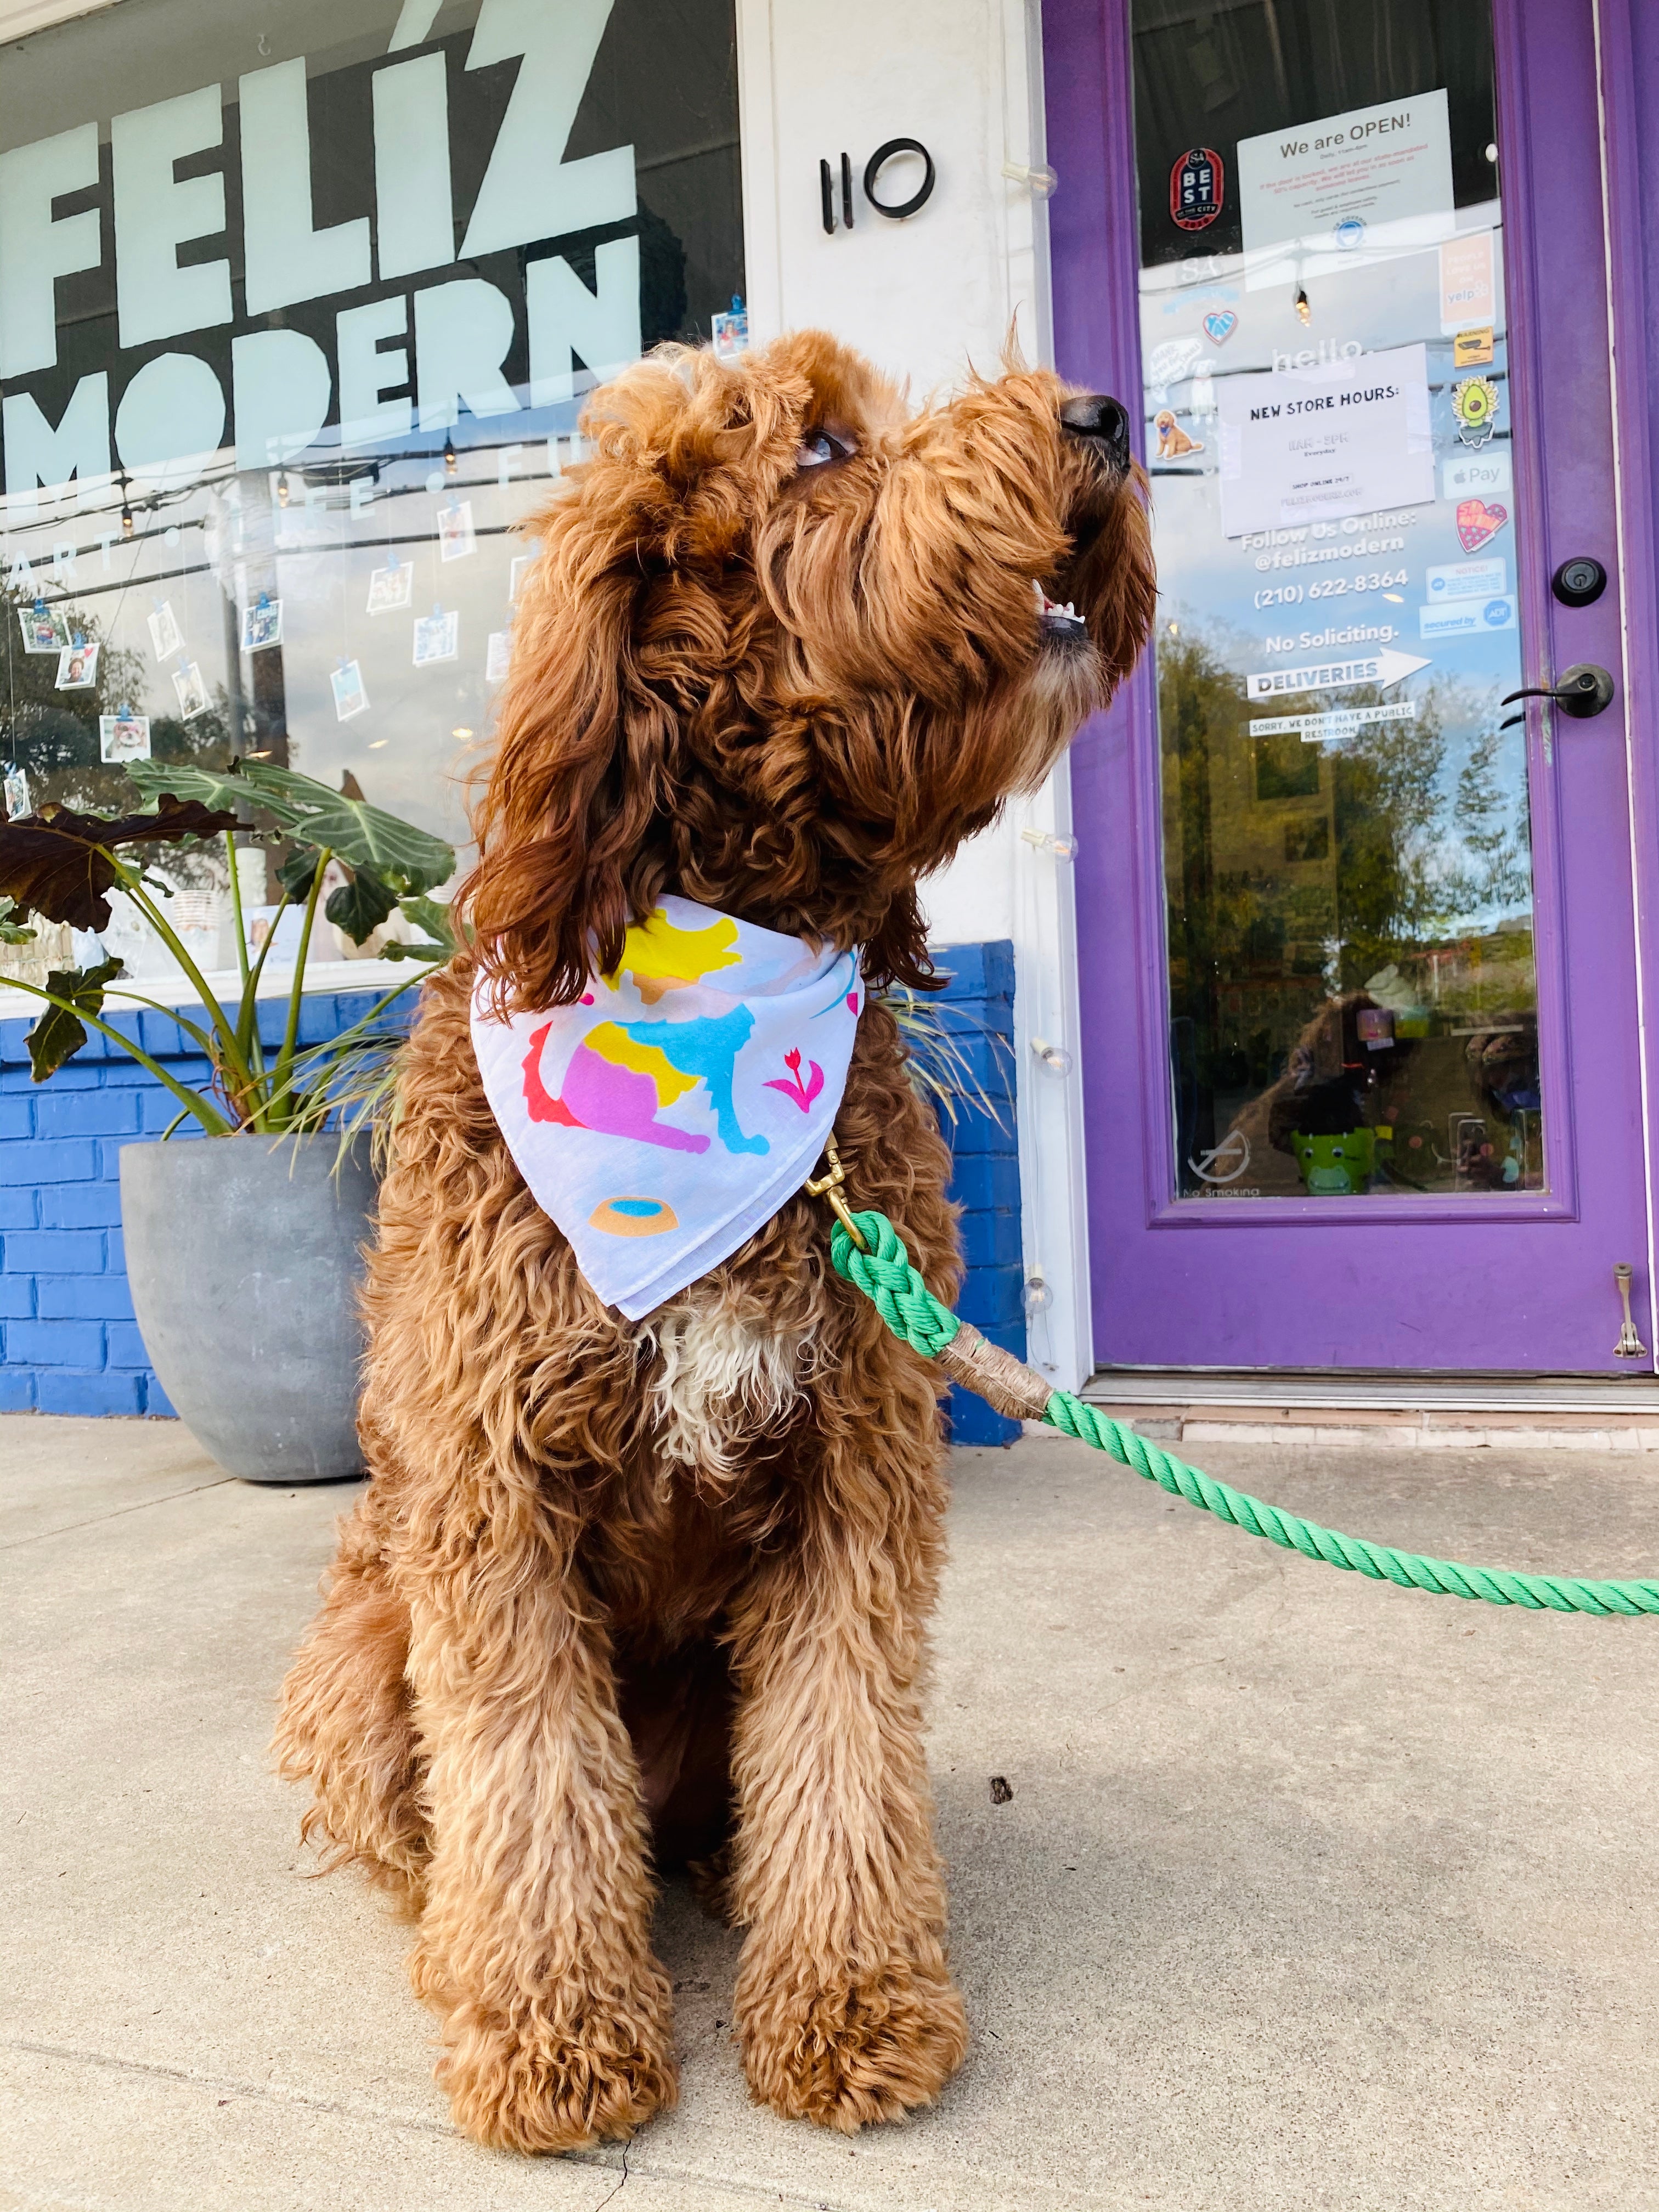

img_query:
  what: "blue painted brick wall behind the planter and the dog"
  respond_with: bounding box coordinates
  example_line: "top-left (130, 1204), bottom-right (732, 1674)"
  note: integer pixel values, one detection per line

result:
top-left (0, 940), bottom-right (1024, 1444)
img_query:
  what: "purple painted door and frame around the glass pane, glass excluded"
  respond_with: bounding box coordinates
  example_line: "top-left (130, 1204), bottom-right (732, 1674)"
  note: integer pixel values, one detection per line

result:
top-left (1044, 0), bottom-right (1659, 1376)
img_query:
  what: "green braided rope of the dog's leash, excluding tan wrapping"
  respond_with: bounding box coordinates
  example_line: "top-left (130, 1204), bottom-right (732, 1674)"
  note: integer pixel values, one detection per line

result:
top-left (830, 1212), bottom-right (1659, 1612)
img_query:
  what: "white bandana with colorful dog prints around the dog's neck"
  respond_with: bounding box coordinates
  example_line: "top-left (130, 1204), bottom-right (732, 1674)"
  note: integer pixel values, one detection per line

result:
top-left (473, 898), bottom-right (865, 1321)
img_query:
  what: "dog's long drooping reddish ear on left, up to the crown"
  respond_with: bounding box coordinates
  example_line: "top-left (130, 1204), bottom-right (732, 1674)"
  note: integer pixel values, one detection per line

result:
top-left (462, 349), bottom-right (810, 1009)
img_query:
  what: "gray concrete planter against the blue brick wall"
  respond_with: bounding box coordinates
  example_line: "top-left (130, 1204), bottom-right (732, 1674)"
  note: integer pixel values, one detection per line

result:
top-left (122, 1137), bottom-right (374, 1482)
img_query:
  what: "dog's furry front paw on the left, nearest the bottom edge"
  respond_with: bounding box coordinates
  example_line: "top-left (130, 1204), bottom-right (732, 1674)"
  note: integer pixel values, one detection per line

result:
top-left (438, 2004), bottom-right (679, 2150)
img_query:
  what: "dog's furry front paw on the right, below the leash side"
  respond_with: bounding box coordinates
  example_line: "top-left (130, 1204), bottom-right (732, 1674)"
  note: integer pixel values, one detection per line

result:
top-left (737, 1951), bottom-right (967, 2135)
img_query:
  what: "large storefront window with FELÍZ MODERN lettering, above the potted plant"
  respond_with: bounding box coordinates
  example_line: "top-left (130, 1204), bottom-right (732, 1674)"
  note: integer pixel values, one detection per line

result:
top-left (0, 0), bottom-right (743, 916)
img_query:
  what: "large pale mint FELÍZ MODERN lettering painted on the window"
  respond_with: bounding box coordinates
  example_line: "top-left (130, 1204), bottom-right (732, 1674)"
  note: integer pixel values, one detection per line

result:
top-left (0, 0), bottom-right (659, 504)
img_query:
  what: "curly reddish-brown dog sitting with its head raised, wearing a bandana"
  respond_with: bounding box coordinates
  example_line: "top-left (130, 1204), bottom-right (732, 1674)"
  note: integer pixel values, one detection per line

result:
top-left (276, 334), bottom-right (1153, 2150)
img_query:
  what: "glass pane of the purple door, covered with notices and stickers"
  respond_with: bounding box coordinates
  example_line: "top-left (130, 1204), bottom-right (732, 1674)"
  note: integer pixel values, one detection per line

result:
top-left (1132, 0), bottom-right (1544, 1199)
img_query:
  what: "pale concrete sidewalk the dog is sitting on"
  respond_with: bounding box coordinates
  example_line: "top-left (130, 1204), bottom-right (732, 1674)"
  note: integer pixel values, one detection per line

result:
top-left (0, 1418), bottom-right (1659, 2212)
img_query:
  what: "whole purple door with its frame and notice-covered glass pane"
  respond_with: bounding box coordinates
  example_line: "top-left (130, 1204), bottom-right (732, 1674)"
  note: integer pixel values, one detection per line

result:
top-left (1044, 0), bottom-right (1652, 1376)
